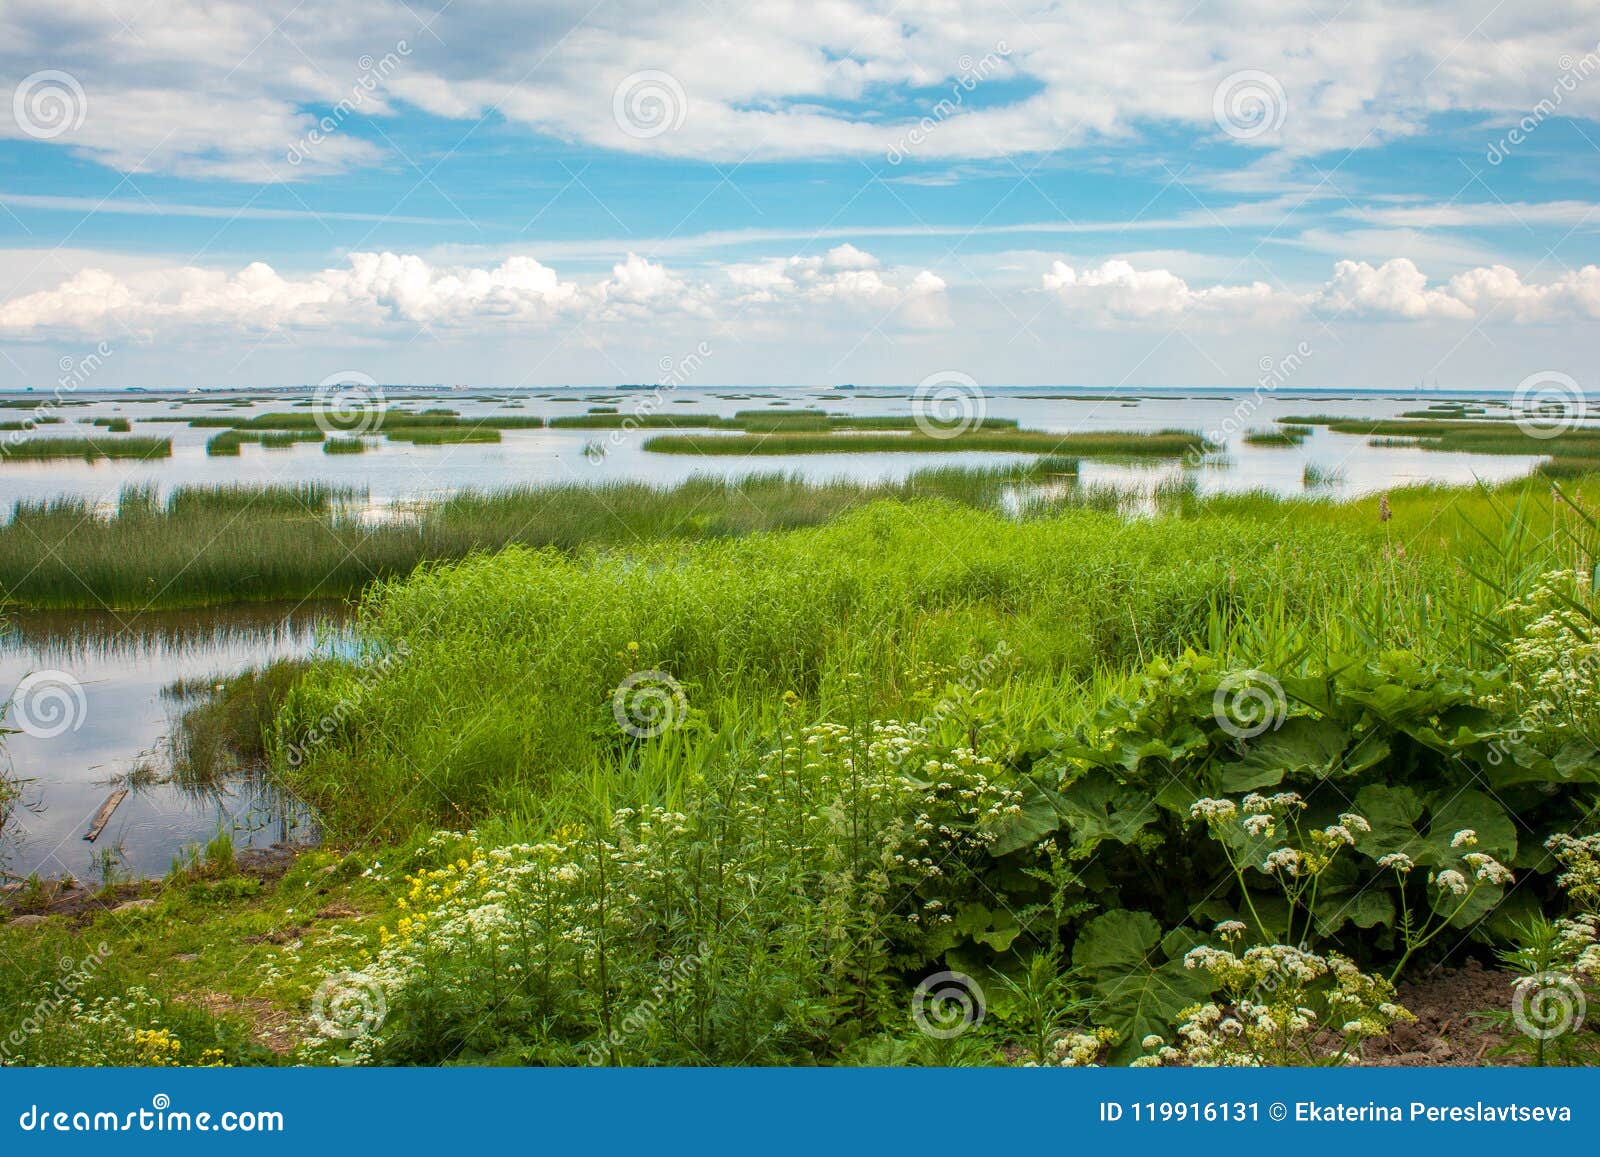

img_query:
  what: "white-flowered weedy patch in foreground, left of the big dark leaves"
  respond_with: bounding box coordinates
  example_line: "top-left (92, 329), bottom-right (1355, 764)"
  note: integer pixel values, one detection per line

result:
top-left (312, 723), bottom-right (1024, 1061)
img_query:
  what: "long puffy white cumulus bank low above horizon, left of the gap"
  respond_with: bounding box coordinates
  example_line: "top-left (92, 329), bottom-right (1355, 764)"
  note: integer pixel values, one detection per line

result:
top-left (0, 245), bottom-right (944, 336)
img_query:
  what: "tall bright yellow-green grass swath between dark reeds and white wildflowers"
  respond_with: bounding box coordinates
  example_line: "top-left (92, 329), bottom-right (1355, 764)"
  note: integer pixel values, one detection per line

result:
top-left (283, 489), bottom-right (1467, 835)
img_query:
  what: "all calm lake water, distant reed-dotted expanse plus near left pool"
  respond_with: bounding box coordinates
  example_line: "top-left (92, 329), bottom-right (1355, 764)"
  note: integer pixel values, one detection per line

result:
top-left (0, 387), bottom-right (1561, 880)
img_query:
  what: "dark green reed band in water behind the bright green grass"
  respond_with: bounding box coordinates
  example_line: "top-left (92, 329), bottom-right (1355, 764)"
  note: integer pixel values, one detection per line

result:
top-left (0, 460), bottom-right (1077, 608)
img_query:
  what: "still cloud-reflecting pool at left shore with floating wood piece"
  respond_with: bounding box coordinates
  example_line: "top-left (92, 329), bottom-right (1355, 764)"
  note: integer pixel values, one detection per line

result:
top-left (0, 607), bottom-right (341, 880)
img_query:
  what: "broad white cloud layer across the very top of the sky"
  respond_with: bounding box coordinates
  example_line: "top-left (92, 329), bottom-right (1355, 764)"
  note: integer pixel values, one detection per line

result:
top-left (0, 0), bottom-right (1600, 181)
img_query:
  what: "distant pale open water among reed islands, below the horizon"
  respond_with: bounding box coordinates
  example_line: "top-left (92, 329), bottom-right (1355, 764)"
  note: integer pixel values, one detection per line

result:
top-left (0, 387), bottom-right (1541, 517)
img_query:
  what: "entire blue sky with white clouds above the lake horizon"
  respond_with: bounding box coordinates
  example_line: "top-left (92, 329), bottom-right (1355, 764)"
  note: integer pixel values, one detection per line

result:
top-left (0, 0), bottom-right (1600, 390)
